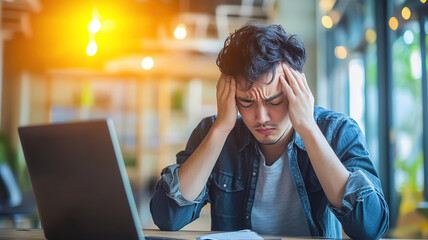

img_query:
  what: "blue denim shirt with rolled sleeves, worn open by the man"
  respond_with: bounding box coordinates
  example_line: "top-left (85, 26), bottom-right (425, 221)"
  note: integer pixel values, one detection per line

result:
top-left (150, 107), bottom-right (389, 239)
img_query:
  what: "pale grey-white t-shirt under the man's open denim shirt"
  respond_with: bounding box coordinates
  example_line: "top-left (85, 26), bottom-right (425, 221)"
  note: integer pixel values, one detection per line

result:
top-left (251, 151), bottom-right (311, 236)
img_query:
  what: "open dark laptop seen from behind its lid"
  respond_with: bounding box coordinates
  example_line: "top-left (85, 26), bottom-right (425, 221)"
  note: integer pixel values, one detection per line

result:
top-left (18, 119), bottom-right (177, 239)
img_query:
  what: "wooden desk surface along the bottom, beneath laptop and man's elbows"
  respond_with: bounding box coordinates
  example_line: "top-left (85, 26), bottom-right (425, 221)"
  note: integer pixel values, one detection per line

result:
top-left (0, 229), bottom-right (324, 240)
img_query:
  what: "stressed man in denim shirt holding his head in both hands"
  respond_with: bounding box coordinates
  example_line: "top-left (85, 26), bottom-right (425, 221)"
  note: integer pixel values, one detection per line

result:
top-left (150, 24), bottom-right (389, 239)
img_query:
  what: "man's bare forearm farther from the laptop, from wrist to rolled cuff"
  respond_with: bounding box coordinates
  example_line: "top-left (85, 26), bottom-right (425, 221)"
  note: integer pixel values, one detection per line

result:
top-left (300, 124), bottom-right (349, 208)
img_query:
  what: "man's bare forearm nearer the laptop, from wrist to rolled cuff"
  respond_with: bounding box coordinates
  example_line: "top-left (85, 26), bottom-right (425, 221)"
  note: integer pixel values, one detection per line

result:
top-left (178, 124), bottom-right (229, 200)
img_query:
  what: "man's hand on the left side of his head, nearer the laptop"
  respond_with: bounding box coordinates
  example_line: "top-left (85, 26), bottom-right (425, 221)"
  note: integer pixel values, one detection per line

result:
top-left (213, 73), bottom-right (238, 132)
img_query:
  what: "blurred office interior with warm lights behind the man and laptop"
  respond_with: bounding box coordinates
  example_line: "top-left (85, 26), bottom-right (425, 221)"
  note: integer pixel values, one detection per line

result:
top-left (0, 0), bottom-right (428, 238)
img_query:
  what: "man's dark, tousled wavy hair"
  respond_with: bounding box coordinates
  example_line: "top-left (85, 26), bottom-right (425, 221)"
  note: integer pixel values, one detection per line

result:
top-left (217, 23), bottom-right (307, 89)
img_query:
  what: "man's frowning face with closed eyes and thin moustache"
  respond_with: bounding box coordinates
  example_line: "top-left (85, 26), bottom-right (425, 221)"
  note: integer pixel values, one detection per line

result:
top-left (236, 64), bottom-right (291, 145)
